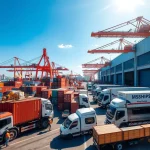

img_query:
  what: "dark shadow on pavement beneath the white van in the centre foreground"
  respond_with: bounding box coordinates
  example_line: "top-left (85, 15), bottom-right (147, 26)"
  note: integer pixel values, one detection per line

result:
top-left (50, 136), bottom-right (91, 150)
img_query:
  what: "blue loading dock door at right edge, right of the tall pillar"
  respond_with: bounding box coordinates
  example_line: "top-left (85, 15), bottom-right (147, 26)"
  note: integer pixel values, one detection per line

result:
top-left (138, 69), bottom-right (150, 87)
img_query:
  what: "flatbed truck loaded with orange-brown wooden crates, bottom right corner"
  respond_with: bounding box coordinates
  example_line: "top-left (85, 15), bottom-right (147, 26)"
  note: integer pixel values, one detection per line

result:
top-left (93, 124), bottom-right (150, 150)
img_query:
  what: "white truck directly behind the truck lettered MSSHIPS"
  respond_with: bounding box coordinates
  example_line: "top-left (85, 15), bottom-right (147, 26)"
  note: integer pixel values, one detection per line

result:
top-left (97, 87), bottom-right (150, 108)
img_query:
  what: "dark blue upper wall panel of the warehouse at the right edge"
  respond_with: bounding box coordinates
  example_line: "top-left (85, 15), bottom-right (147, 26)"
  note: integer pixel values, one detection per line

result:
top-left (137, 52), bottom-right (150, 67)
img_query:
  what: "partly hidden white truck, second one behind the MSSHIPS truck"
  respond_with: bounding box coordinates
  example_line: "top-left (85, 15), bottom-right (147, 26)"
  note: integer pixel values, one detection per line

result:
top-left (93, 84), bottom-right (122, 102)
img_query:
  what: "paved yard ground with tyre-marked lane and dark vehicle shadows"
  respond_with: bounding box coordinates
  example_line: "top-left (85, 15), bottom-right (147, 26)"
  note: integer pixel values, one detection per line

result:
top-left (2, 82), bottom-right (150, 150)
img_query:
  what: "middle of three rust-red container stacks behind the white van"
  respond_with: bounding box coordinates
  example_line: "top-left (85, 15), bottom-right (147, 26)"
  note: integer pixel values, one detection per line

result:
top-left (64, 91), bottom-right (74, 110)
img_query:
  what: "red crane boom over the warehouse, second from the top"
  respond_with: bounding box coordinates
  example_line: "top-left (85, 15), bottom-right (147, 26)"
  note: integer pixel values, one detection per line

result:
top-left (88, 38), bottom-right (135, 54)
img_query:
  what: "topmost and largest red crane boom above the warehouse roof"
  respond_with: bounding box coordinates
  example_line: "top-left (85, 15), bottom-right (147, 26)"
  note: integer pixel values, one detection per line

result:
top-left (91, 16), bottom-right (150, 38)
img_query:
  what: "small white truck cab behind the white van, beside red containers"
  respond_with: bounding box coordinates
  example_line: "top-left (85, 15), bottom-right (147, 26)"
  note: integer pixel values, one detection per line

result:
top-left (79, 94), bottom-right (90, 108)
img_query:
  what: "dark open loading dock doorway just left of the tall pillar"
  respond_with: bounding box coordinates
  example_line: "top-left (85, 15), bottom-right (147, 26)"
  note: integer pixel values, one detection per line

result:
top-left (124, 71), bottom-right (134, 86)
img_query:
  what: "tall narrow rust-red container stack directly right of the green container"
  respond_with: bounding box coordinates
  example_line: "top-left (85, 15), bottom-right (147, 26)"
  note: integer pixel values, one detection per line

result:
top-left (58, 89), bottom-right (67, 111)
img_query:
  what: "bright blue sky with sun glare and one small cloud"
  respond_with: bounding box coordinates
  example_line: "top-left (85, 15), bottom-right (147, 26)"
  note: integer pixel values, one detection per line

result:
top-left (0, 0), bottom-right (150, 77)
